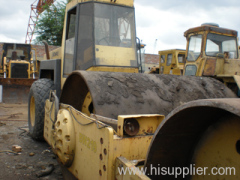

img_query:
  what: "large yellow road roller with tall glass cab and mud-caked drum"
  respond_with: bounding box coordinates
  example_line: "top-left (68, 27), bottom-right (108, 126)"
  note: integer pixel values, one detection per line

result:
top-left (28, 0), bottom-right (240, 179)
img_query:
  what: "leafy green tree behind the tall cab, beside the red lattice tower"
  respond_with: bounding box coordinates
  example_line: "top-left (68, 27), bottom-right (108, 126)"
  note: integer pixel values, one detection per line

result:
top-left (34, 0), bottom-right (69, 46)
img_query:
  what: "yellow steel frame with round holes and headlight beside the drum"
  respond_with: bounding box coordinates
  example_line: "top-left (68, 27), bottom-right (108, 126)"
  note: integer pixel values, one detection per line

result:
top-left (44, 100), bottom-right (164, 180)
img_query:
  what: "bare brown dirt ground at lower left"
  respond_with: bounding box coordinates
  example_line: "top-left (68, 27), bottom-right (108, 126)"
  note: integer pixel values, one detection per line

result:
top-left (0, 103), bottom-right (63, 180)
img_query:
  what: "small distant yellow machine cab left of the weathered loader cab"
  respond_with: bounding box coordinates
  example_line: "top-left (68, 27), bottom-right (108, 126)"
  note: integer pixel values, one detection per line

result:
top-left (149, 49), bottom-right (186, 75)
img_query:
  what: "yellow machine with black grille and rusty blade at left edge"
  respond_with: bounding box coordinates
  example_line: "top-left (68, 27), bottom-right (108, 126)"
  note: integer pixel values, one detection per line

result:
top-left (0, 43), bottom-right (39, 103)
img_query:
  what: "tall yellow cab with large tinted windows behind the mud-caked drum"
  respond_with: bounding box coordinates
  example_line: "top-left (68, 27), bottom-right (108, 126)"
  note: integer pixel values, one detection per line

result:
top-left (62, 0), bottom-right (138, 79)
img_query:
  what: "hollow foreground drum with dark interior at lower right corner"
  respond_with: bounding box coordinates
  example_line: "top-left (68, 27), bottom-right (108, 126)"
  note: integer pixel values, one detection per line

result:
top-left (145, 99), bottom-right (240, 180)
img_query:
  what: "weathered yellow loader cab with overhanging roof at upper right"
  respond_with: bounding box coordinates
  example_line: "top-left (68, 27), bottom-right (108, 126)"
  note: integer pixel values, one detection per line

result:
top-left (184, 23), bottom-right (240, 77)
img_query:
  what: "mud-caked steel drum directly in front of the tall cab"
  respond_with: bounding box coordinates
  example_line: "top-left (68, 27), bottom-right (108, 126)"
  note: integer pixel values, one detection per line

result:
top-left (60, 71), bottom-right (236, 119)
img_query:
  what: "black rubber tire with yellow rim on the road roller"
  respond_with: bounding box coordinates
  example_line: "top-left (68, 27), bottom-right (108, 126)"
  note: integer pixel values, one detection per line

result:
top-left (28, 79), bottom-right (55, 141)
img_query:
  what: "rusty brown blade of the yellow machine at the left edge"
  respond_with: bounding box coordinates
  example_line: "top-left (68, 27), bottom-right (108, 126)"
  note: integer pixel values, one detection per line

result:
top-left (0, 78), bottom-right (36, 104)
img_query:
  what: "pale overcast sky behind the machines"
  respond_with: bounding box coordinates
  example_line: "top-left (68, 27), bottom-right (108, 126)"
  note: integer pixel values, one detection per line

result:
top-left (0, 0), bottom-right (240, 54)
